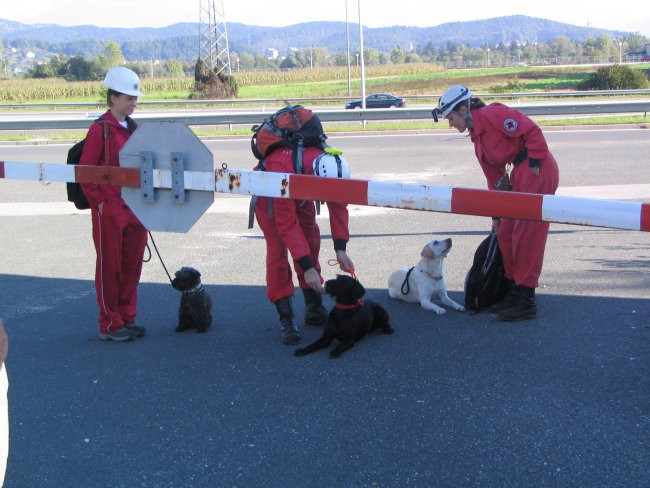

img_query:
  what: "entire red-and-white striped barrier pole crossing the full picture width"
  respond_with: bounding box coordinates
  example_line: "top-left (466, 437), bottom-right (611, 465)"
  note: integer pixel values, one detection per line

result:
top-left (0, 161), bottom-right (650, 232)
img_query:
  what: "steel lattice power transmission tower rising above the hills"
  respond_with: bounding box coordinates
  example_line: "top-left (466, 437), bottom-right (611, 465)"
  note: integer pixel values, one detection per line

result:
top-left (199, 0), bottom-right (232, 74)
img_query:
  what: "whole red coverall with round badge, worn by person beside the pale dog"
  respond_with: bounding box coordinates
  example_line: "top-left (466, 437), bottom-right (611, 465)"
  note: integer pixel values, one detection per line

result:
top-left (470, 103), bottom-right (559, 288)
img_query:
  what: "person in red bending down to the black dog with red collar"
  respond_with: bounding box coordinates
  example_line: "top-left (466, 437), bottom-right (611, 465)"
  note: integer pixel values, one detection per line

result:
top-left (255, 147), bottom-right (353, 345)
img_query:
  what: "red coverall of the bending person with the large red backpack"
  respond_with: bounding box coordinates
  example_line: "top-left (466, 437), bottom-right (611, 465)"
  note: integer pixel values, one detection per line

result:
top-left (255, 147), bottom-right (350, 303)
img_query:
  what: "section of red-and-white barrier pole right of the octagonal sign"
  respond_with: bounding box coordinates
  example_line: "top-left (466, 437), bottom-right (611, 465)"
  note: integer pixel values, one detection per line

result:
top-left (216, 170), bottom-right (650, 232)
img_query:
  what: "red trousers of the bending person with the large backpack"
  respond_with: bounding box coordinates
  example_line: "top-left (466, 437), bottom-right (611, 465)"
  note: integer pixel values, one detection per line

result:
top-left (255, 197), bottom-right (323, 303)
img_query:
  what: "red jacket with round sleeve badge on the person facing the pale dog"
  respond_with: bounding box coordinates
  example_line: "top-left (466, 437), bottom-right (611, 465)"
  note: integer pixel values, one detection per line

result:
top-left (470, 103), bottom-right (550, 190)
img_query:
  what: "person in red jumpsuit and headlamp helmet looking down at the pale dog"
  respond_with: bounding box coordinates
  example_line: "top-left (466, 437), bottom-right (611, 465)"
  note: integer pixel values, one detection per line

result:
top-left (434, 85), bottom-right (559, 322)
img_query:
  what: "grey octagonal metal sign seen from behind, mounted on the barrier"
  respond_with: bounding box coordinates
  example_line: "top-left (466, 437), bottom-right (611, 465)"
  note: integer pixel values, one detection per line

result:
top-left (120, 122), bottom-right (214, 232)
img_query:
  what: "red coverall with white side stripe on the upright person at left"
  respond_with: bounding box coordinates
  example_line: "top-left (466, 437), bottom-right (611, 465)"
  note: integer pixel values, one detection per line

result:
top-left (79, 110), bottom-right (147, 334)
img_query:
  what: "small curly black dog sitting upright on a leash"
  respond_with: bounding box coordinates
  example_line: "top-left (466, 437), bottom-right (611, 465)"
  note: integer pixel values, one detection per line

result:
top-left (172, 266), bottom-right (212, 333)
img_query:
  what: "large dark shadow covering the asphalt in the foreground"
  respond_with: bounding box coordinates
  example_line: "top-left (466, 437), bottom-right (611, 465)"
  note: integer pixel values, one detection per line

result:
top-left (0, 274), bottom-right (650, 488)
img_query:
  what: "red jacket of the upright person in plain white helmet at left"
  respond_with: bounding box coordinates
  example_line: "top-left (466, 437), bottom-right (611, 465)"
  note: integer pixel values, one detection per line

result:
top-left (79, 110), bottom-right (131, 208)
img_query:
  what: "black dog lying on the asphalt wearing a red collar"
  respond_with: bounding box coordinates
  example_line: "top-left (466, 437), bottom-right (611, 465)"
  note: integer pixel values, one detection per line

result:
top-left (294, 275), bottom-right (395, 358)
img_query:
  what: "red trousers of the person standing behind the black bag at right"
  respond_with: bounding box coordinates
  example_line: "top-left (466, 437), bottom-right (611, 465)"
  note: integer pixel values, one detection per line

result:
top-left (497, 153), bottom-right (559, 288)
